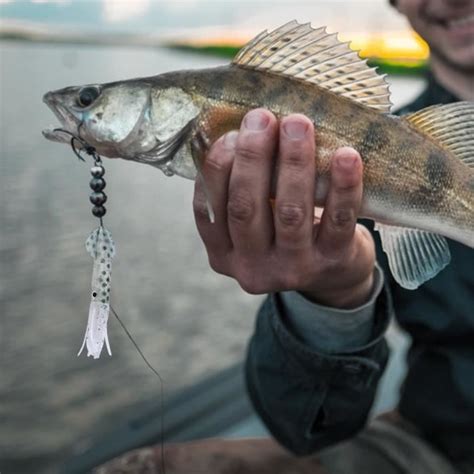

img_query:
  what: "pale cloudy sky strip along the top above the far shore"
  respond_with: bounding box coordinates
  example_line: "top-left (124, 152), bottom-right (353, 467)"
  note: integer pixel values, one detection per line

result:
top-left (0, 0), bottom-right (407, 34)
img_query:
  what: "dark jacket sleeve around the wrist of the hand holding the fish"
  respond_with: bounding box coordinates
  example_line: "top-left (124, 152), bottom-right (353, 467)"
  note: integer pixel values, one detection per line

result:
top-left (245, 278), bottom-right (392, 455)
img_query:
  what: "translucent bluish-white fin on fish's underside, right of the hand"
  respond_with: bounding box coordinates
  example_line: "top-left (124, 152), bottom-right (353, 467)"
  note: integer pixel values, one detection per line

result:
top-left (375, 223), bottom-right (451, 290)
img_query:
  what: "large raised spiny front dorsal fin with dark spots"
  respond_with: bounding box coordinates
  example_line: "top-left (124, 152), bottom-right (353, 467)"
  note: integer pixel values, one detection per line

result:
top-left (232, 21), bottom-right (392, 112)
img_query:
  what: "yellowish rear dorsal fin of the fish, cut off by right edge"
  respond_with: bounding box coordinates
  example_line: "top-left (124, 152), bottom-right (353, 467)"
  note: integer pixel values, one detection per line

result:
top-left (403, 101), bottom-right (474, 168)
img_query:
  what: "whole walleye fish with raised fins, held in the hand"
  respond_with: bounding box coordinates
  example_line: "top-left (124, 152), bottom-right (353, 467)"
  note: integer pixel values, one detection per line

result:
top-left (43, 21), bottom-right (474, 289)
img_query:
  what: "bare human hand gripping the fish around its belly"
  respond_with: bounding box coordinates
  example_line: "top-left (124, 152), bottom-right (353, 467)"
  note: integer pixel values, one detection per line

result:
top-left (193, 109), bottom-right (375, 308)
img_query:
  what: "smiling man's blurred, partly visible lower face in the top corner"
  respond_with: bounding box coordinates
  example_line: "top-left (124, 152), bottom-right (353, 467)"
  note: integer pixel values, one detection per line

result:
top-left (396, 0), bottom-right (474, 72)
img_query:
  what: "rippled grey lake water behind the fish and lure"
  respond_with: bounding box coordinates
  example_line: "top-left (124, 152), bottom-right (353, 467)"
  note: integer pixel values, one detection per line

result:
top-left (0, 42), bottom-right (420, 473)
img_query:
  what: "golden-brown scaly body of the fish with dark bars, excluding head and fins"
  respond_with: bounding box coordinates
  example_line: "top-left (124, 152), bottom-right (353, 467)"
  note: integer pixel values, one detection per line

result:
top-left (161, 67), bottom-right (474, 241)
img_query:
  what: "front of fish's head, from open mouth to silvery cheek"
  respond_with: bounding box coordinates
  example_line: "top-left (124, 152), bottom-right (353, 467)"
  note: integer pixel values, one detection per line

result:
top-left (43, 80), bottom-right (150, 158)
